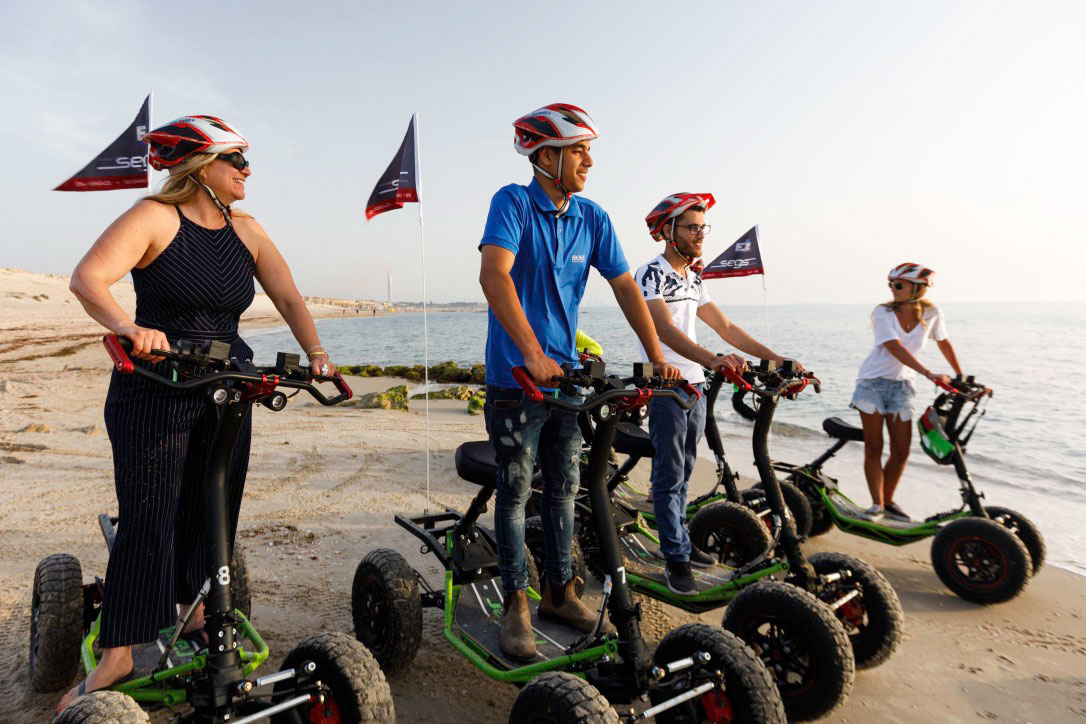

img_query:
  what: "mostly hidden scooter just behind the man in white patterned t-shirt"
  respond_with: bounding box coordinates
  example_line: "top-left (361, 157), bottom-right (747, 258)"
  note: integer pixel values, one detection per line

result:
top-left (581, 369), bottom-right (812, 540)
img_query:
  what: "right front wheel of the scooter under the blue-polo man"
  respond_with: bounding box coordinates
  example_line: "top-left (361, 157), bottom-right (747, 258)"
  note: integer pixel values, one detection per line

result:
top-left (649, 623), bottom-right (786, 724)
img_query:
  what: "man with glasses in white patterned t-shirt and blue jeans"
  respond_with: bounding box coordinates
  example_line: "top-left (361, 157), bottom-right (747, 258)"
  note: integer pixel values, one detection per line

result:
top-left (634, 193), bottom-right (799, 596)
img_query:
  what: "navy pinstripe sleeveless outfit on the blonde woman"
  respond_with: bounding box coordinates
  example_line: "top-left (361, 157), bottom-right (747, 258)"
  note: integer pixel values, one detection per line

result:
top-left (100, 208), bottom-right (255, 647)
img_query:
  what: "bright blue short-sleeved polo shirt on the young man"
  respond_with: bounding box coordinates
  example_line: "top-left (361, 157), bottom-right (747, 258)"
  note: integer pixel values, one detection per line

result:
top-left (479, 179), bottom-right (630, 388)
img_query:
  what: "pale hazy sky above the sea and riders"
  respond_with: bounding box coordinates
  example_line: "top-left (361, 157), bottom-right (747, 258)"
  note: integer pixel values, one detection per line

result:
top-left (0, 0), bottom-right (1086, 308)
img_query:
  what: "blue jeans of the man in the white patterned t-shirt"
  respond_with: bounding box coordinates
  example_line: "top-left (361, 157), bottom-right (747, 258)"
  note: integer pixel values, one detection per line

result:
top-left (648, 384), bottom-right (705, 563)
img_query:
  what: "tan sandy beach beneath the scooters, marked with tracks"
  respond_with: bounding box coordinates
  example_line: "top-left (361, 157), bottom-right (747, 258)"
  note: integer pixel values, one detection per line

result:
top-left (0, 269), bottom-right (1086, 724)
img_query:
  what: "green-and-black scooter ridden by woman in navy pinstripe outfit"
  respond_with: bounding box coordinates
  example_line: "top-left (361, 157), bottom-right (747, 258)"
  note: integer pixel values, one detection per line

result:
top-left (29, 334), bottom-right (395, 724)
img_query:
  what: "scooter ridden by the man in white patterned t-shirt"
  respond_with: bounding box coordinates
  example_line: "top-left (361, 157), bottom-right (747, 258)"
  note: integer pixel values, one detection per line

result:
top-left (547, 360), bottom-right (904, 721)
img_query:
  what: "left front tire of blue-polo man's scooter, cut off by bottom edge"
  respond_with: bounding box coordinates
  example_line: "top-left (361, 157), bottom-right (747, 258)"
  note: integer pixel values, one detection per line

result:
top-left (509, 671), bottom-right (619, 724)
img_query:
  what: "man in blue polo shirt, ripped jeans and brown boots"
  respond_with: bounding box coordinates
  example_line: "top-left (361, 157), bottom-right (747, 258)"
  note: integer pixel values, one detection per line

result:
top-left (479, 103), bottom-right (678, 660)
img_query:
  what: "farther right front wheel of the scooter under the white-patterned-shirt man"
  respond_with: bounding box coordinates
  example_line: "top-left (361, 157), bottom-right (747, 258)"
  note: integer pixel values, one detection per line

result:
top-left (808, 552), bottom-right (905, 669)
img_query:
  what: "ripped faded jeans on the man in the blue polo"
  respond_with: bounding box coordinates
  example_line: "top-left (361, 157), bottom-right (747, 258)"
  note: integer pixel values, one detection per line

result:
top-left (483, 385), bottom-right (583, 593)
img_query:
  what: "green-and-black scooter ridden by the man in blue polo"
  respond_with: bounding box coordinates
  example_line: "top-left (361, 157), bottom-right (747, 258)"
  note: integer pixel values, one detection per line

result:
top-left (352, 361), bottom-right (785, 724)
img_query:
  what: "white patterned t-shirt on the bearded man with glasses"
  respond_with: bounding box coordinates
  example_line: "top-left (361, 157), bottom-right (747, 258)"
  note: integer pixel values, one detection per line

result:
top-left (633, 254), bottom-right (712, 383)
